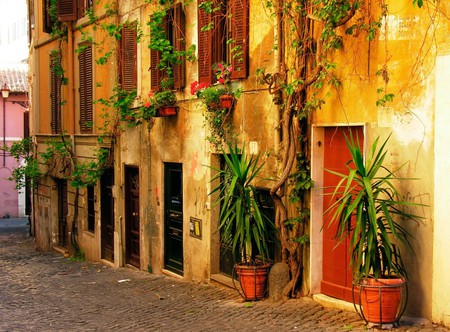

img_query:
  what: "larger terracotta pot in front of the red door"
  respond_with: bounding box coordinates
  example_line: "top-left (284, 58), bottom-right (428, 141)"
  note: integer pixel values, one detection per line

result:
top-left (359, 278), bottom-right (406, 324)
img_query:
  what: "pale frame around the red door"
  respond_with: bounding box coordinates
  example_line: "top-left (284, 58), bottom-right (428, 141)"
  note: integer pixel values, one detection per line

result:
top-left (309, 122), bottom-right (367, 295)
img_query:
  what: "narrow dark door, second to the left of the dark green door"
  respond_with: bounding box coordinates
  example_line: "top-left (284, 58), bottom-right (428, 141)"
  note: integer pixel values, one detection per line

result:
top-left (100, 168), bottom-right (114, 262)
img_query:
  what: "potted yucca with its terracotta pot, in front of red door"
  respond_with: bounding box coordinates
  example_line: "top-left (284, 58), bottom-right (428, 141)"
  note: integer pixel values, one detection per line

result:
top-left (325, 134), bottom-right (423, 325)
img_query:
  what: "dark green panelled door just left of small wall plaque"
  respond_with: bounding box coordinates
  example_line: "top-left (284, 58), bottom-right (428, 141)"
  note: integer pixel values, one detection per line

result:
top-left (164, 163), bottom-right (184, 275)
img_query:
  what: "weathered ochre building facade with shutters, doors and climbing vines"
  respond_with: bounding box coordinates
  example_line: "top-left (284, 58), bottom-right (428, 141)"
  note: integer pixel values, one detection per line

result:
top-left (29, 0), bottom-right (450, 324)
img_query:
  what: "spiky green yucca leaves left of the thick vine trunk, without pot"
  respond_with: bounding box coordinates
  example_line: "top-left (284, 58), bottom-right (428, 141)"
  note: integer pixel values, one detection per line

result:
top-left (211, 144), bottom-right (275, 264)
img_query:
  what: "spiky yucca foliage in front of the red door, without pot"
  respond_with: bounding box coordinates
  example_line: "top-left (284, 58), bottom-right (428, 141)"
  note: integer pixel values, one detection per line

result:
top-left (325, 134), bottom-right (423, 281)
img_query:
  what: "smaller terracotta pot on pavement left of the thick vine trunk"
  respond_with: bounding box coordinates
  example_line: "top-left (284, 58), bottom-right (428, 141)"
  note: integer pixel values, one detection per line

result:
top-left (234, 264), bottom-right (270, 301)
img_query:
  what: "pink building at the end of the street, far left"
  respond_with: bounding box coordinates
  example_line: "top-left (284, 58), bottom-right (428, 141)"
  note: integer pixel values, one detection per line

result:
top-left (0, 64), bottom-right (28, 218)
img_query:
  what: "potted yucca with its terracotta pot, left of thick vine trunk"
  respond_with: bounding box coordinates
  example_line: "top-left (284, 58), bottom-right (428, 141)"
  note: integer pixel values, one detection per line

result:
top-left (211, 144), bottom-right (276, 300)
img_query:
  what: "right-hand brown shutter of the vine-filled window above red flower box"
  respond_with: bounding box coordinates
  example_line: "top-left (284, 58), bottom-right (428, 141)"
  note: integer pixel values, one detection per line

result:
top-left (172, 3), bottom-right (186, 89)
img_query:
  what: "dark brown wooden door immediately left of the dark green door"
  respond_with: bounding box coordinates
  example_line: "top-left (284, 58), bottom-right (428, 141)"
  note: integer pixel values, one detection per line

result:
top-left (125, 166), bottom-right (141, 268)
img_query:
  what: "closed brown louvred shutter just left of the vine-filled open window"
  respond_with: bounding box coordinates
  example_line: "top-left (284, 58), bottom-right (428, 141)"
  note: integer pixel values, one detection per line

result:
top-left (120, 25), bottom-right (137, 91)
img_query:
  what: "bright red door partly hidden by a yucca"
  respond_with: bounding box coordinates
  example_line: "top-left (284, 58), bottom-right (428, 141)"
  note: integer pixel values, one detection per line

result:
top-left (321, 127), bottom-right (363, 302)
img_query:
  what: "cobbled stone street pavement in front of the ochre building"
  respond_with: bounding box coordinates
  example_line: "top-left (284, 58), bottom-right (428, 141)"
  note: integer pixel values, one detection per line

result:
top-left (0, 219), bottom-right (449, 332)
